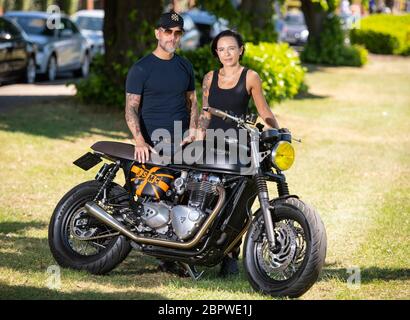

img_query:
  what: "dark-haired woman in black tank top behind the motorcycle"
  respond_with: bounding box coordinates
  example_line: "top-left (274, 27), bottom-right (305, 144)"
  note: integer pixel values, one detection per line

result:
top-left (197, 30), bottom-right (279, 276)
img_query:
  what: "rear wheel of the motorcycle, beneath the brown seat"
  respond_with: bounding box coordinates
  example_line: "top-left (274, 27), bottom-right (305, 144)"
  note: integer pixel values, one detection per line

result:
top-left (48, 180), bottom-right (131, 274)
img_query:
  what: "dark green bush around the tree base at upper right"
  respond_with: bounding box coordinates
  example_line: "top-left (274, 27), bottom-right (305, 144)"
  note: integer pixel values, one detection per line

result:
top-left (301, 15), bottom-right (367, 67)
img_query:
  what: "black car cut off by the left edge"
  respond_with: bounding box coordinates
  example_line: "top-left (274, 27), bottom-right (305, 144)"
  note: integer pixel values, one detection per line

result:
top-left (0, 17), bottom-right (36, 84)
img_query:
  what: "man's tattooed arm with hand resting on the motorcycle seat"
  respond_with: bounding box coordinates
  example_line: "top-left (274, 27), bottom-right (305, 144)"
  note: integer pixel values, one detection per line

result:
top-left (125, 93), bottom-right (153, 163)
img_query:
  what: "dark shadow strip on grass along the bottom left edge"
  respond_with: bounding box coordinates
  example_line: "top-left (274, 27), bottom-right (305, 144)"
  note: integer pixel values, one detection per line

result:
top-left (0, 283), bottom-right (166, 300)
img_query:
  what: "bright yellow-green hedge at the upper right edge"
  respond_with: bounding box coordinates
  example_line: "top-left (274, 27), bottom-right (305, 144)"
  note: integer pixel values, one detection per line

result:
top-left (350, 14), bottom-right (410, 55)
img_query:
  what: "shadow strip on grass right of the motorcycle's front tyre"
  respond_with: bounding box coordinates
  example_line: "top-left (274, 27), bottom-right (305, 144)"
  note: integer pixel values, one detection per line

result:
top-left (320, 267), bottom-right (410, 284)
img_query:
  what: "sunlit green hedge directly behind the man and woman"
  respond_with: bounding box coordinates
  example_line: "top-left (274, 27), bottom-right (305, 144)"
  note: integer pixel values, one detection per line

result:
top-left (74, 43), bottom-right (305, 108)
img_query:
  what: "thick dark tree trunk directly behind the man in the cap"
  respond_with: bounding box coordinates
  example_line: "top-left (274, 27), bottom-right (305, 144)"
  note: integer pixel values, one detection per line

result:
top-left (104, 0), bottom-right (162, 85)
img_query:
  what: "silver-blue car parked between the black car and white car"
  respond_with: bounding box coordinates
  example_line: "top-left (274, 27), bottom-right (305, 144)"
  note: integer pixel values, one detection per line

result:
top-left (5, 11), bottom-right (91, 81)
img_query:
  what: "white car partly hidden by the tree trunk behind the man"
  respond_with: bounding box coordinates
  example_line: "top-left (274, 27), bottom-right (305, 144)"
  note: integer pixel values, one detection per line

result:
top-left (71, 10), bottom-right (105, 57)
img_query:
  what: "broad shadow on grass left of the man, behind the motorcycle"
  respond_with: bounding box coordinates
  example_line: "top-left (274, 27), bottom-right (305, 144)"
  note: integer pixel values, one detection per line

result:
top-left (0, 99), bottom-right (128, 140)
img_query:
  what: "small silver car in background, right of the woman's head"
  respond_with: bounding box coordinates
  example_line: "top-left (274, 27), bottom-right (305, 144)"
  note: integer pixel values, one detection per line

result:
top-left (279, 11), bottom-right (309, 45)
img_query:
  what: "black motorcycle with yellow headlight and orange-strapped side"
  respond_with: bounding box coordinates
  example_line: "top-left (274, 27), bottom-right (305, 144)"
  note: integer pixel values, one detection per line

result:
top-left (49, 107), bottom-right (327, 298)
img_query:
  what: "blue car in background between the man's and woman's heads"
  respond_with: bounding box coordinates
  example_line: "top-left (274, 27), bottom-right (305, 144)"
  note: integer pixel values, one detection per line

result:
top-left (184, 8), bottom-right (228, 46)
